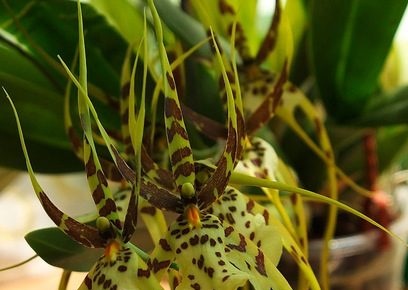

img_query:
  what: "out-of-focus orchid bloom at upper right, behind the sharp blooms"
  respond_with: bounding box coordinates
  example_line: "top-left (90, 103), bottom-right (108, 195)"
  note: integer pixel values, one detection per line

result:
top-left (184, 0), bottom-right (338, 286)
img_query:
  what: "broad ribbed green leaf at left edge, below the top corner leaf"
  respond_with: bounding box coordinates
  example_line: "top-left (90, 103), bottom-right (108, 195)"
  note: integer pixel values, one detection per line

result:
top-left (0, 44), bottom-right (83, 173)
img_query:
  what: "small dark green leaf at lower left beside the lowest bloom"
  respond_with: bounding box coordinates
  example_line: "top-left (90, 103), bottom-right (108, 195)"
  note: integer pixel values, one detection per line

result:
top-left (25, 228), bottom-right (103, 272)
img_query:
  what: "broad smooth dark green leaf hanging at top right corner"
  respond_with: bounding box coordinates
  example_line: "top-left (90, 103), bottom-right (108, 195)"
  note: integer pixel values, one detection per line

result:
top-left (310, 0), bottom-right (408, 120)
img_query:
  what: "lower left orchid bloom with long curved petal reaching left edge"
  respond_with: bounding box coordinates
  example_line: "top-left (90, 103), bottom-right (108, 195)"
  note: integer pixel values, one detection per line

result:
top-left (6, 1), bottom-right (162, 290)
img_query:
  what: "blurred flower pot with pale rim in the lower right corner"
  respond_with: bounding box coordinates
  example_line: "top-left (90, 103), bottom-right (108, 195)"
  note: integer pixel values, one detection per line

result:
top-left (279, 186), bottom-right (408, 290)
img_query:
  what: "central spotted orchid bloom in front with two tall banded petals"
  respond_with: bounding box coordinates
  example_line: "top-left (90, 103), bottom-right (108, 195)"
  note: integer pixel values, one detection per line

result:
top-left (106, 1), bottom-right (290, 289)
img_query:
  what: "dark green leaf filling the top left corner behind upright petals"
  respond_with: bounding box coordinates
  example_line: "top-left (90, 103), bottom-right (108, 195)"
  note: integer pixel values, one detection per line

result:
top-left (0, 0), bottom-right (126, 95)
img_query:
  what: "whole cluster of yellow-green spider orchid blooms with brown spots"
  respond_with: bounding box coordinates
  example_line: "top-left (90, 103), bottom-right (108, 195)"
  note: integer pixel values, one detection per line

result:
top-left (2, 0), bottom-right (404, 290)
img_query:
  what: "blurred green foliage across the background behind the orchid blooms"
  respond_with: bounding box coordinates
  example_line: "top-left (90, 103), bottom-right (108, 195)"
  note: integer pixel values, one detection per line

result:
top-left (0, 0), bottom-right (408, 194)
